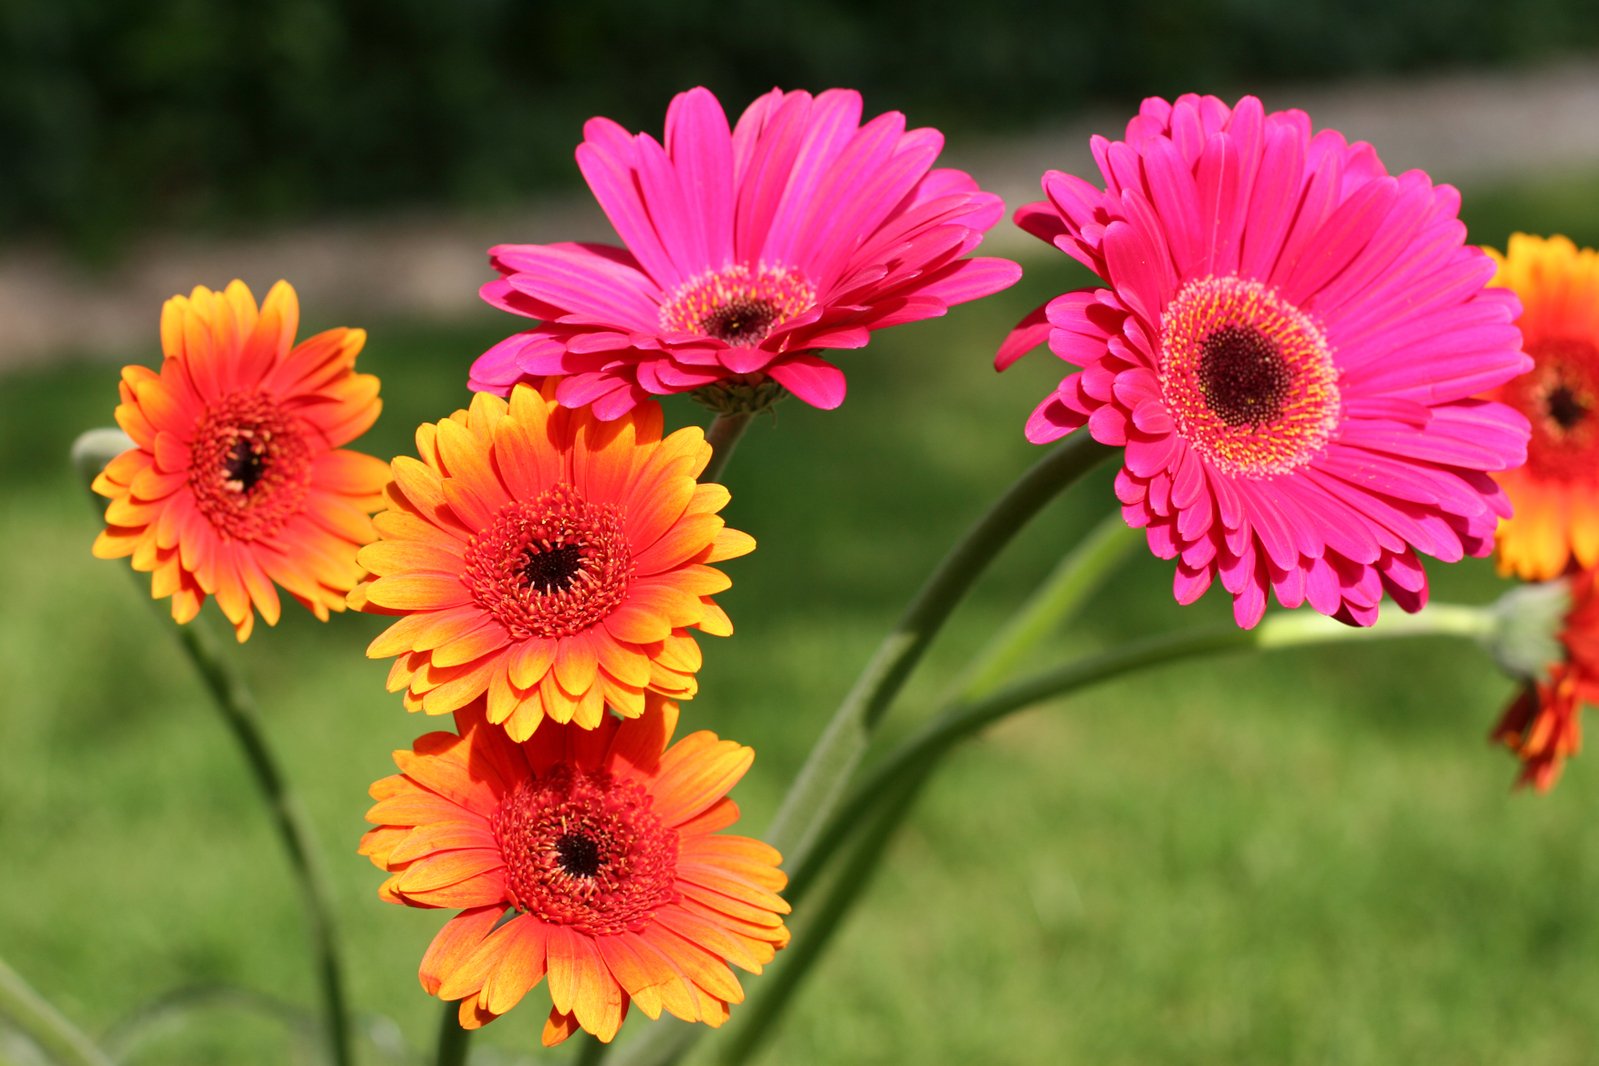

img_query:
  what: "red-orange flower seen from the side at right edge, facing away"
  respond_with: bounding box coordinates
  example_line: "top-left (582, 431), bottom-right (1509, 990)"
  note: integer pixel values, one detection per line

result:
top-left (1492, 571), bottom-right (1599, 793)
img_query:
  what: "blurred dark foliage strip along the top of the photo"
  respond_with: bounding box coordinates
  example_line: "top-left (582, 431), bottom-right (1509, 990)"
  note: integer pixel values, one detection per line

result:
top-left (0, 0), bottom-right (1599, 257)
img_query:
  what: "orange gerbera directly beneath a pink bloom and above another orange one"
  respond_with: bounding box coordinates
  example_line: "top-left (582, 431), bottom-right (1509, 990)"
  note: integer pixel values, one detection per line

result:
top-left (350, 385), bottom-right (755, 740)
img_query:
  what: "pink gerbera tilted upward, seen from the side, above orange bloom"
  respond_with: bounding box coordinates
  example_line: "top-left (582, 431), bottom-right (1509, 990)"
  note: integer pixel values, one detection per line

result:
top-left (469, 88), bottom-right (1022, 419)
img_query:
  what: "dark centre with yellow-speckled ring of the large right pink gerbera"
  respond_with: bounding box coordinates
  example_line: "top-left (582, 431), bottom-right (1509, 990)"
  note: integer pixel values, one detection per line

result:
top-left (1161, 276), bottom-right (1340, 478)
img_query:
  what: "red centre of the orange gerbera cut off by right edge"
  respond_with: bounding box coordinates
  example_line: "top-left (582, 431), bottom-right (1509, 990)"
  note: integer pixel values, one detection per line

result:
top-left (1505, 339), bottom-right (1599, 481)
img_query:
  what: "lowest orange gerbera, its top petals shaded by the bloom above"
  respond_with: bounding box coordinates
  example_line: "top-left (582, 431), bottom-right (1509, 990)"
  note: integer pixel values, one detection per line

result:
top-left (361, 694), bottom-right (788, 1045)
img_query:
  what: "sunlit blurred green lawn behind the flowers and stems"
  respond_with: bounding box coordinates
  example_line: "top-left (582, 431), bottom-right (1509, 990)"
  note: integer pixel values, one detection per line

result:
top-left (0, 179), bottom-right (1599, 1066)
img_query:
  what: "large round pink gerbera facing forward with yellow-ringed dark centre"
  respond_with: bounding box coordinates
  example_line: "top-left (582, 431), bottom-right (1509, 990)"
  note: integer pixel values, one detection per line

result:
top-left (998, 96), bottom-right (1529, 626)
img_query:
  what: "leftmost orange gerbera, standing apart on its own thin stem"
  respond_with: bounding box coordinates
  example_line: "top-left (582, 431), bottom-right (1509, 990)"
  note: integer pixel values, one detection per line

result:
top-left (93, 281), bottom-right (389, 641)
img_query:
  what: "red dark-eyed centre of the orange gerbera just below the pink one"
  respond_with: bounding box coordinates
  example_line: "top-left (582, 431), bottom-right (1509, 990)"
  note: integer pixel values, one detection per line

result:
top-left (464, 484), bottom-right (633, 639)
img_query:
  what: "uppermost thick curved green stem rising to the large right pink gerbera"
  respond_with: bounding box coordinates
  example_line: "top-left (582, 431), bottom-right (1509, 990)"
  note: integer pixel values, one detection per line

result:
top-left (766, 433), bottom-right (1110, 863)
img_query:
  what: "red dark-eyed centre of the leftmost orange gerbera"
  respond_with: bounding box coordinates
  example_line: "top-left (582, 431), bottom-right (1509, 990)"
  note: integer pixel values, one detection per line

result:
top-left (189, 393), bottom-right (312, 540)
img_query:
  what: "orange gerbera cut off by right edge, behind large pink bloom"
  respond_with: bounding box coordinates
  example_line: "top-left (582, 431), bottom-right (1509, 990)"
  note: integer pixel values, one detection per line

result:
top-left (1487, 233), bottom-right (1599, 582)
